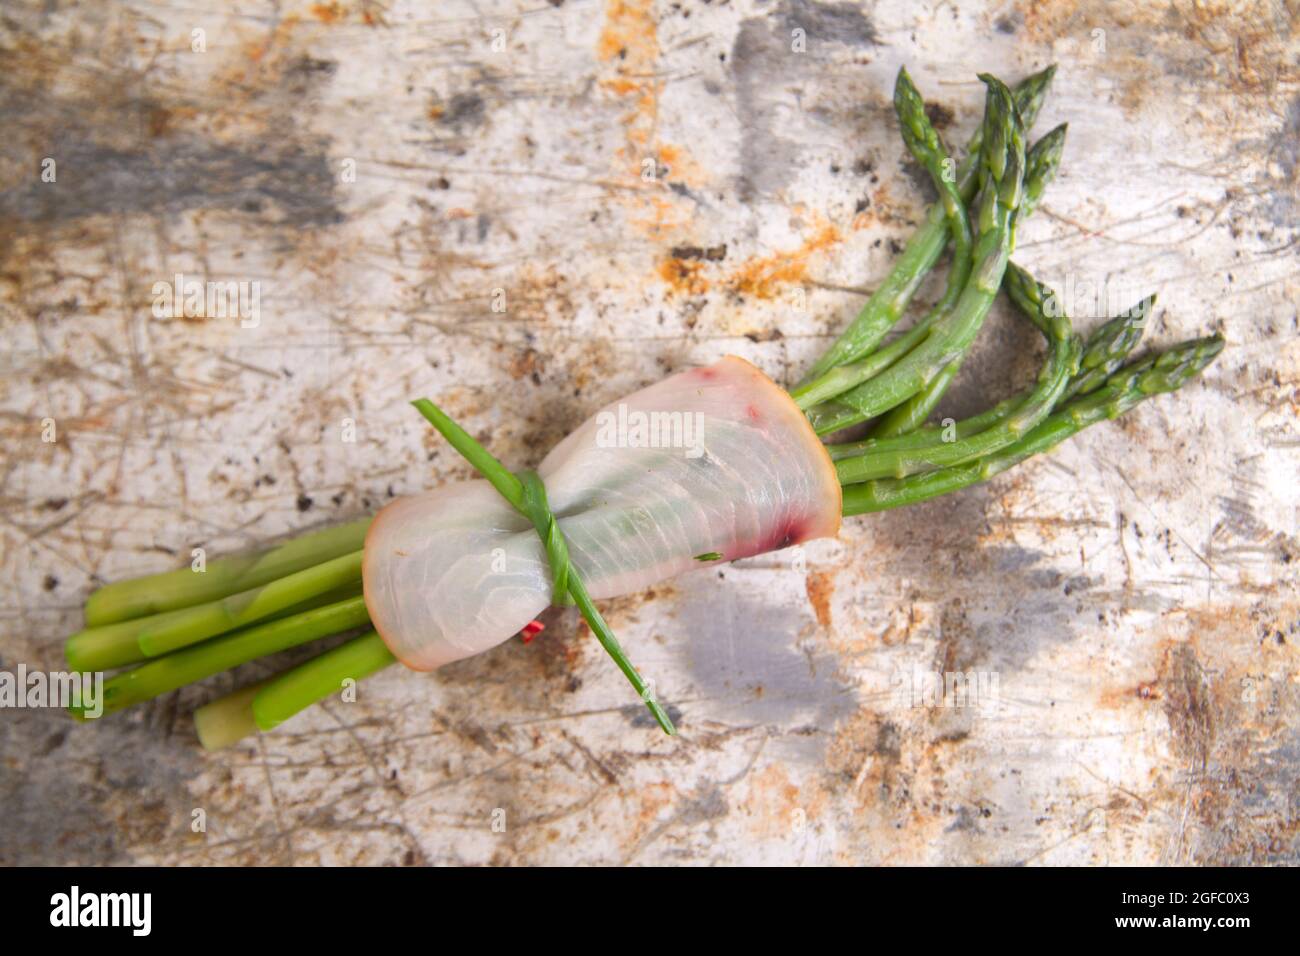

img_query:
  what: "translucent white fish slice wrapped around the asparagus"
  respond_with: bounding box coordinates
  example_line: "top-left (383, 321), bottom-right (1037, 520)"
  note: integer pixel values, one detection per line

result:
top-left (363, 355), bottom-right (840, 670)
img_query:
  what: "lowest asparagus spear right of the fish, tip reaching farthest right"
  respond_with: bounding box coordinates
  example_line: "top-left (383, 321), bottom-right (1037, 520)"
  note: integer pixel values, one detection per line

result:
top-left (844, 336), bottom-right (1223, 515)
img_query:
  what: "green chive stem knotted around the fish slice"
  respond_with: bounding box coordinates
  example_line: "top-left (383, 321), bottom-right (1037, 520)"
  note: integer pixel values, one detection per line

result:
top-left (411, 398), bottom-right (677, 736)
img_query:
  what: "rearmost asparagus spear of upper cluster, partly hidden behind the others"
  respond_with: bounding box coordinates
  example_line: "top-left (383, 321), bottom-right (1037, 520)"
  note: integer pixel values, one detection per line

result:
top-left (803, 65), bottom-right (1056, 384)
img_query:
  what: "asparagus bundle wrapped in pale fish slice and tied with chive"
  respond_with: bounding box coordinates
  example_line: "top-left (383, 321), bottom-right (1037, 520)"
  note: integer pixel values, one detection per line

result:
top-left (58, 68), bottom-right (1223, 748)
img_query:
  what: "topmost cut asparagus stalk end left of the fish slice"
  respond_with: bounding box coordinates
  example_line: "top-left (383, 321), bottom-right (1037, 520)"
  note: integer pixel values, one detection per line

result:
top-left (86, 518), bottom-right (372, 628)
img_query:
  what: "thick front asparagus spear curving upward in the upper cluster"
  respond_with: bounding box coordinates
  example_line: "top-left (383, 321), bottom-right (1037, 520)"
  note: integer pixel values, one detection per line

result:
top-left (796, 74), bottom-right (1024, 434)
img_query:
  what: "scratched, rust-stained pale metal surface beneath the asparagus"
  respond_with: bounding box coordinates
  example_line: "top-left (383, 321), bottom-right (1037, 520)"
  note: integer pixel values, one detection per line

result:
top-left (0, 0), bottom-right (1300, 864)
